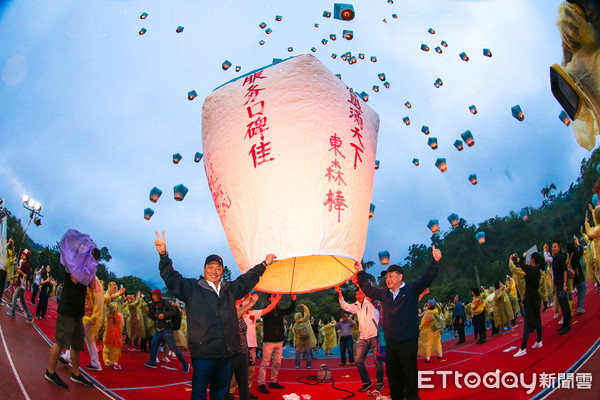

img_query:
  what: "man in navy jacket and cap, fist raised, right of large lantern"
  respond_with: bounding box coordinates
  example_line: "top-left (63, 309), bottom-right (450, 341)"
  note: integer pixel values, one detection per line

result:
top-left (354, 246), bottom-right (442, 400)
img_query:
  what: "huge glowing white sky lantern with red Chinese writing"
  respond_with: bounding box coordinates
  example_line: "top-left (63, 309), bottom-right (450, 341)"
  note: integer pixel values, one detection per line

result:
top-left (202, 54), bottom-right (379, 293)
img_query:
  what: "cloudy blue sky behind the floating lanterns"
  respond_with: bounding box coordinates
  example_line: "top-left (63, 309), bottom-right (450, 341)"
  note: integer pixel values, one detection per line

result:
top-left (0, 0), bottom-right (589, 288)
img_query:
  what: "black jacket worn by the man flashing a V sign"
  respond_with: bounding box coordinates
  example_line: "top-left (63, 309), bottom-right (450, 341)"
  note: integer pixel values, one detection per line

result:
top-left (158, 254), bottom-right (265, 358)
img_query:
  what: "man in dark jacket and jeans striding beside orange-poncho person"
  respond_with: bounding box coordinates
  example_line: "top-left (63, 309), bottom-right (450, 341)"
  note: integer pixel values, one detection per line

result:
top-left (144, 289), bottom-right (190, 373)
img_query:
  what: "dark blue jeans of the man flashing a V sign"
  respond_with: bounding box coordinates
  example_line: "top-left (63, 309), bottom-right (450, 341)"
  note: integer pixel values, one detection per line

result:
top-left (192, 357), bottom-right (231, 400)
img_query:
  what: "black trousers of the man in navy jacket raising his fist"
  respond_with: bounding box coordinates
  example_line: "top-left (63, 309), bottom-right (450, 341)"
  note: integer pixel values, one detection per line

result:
top-left (385, 339), bottom-right (419, 400)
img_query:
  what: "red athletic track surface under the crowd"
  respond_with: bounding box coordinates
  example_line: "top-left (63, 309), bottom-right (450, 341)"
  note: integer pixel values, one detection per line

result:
top-left (0, 285), bottom-right (600, 400)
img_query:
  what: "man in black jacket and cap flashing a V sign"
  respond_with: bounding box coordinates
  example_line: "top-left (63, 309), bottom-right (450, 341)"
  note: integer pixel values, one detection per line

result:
top-left (154, 231), bottom-right (275, 400)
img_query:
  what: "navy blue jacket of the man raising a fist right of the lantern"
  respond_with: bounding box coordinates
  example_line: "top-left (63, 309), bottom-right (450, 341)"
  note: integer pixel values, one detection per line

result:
top-left (356, 261), bottom-right (440, 341)
